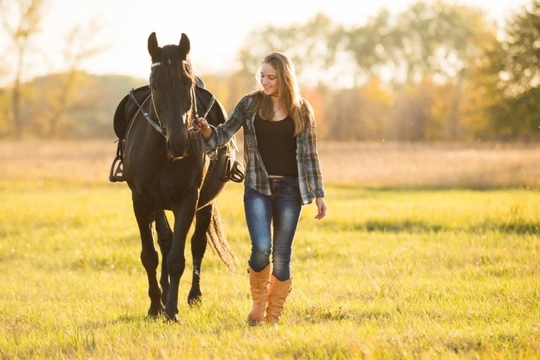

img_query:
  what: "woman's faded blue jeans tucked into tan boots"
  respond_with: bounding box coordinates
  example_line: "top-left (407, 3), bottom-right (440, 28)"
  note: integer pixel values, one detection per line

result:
top-left (244, 177), bottom-right (302, 281)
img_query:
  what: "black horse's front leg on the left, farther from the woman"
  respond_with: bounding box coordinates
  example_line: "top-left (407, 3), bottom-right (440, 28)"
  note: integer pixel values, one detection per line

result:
top-left (133, 198), bottom-right (163, 317)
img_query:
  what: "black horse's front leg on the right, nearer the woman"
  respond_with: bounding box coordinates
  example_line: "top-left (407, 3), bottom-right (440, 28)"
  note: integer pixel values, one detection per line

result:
top-left (165, 189), bottom-right (198, 321)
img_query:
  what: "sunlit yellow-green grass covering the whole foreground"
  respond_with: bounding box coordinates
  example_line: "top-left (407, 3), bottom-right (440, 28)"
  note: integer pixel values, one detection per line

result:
top-left (0, 182), bottom-right (540, 359)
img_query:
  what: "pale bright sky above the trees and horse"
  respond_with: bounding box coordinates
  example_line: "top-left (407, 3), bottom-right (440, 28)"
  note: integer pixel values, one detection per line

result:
top-left (0, 0), bottom-right (529, 82)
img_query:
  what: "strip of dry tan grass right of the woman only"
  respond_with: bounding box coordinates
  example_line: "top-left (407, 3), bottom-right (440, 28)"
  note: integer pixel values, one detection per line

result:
top-left (319, 143), bottom-right (540, 189)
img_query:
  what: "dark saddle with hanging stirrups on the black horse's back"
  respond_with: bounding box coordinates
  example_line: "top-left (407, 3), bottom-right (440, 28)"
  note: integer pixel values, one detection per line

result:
top-left (109, 81), bottom-right (244, 183)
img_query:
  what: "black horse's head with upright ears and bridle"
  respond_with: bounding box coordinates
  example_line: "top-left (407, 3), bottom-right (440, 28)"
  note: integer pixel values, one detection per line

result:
top-left (148, 33), bottom-right (195, 159)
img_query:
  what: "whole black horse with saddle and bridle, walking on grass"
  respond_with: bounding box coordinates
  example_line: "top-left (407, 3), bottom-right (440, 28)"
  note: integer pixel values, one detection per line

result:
top-left (111, 33), bottom-right (241, 321)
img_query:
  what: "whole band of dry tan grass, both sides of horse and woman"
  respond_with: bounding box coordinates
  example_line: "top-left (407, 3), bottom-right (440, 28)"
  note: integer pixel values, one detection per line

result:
top-left (0, 139), bottom-right (540, 189)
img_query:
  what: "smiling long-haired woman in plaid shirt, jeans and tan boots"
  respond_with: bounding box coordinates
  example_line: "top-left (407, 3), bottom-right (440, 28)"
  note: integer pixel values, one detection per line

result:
top-left (194, 52), bottom-right (326, 326)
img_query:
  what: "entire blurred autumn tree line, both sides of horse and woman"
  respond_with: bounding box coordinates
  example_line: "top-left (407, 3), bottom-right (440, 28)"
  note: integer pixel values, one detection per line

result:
top-left (0, 0), bottom-right (540, 141)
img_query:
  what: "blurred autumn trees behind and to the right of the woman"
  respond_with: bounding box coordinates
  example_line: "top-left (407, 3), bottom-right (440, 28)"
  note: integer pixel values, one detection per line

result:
top-left (231, 0), bottom-right (540, 141)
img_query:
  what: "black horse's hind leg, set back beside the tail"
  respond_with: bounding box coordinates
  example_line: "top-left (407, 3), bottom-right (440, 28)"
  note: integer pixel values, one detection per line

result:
top-left (188, 203), bottom-right (213, 306)
